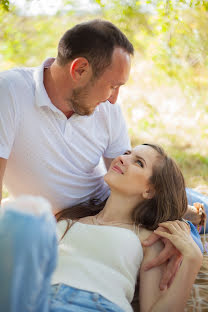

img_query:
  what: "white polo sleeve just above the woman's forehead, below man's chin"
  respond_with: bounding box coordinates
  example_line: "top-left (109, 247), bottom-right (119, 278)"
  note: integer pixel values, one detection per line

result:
top-left (104, 103), bottom-right (131, 158)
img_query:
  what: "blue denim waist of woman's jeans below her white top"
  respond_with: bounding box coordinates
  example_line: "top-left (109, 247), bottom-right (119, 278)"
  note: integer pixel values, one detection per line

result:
top-left (50, 284), bottom-right (123, 312)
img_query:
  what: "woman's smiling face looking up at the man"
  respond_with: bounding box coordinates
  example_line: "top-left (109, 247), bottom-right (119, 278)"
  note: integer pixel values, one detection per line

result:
top-left (104, 145), bottom-right (158, 198)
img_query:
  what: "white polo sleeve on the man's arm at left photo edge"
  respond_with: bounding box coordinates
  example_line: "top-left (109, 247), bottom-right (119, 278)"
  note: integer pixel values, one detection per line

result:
top-left (0, 76), bottom-right (17, 159)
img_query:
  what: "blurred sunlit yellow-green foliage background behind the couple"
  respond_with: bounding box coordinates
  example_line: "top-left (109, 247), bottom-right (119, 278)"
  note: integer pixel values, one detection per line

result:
top-left (0, 0), bottom-right (208, 196)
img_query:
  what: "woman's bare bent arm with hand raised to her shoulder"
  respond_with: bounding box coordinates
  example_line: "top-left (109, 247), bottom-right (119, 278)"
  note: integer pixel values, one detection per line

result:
top-left (140, 221), bottom-right (202, 312)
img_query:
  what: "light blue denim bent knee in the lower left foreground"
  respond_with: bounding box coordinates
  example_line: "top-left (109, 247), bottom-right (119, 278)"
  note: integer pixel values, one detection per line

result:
top-left (0, 210), bottom-right (57, 312)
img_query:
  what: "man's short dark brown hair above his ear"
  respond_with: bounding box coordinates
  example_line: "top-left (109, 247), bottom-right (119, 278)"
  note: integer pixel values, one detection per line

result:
top-left (57, 19), bottom-right (134, 78)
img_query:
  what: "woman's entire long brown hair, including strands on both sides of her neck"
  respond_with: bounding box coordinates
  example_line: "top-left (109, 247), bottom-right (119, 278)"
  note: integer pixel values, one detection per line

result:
top-left (56, 144), bottom-right (188, 235)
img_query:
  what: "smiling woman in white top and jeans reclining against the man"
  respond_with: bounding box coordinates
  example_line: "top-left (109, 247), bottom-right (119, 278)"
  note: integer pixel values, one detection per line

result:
top-left (0, 144), bottom-right (202, 312)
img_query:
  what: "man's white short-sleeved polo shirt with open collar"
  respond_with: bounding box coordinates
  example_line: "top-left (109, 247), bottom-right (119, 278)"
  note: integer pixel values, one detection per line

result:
top-left (0, 59), bottom-right (130, 209)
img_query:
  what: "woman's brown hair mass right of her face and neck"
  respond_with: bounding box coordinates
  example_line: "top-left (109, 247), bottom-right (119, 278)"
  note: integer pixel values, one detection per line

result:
top-left (132, 144), bottom-right (188, 230)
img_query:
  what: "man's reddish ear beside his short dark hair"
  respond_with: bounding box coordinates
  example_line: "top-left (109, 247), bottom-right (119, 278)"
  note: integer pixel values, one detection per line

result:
top-left (70, 57), bottom-right (92, 83)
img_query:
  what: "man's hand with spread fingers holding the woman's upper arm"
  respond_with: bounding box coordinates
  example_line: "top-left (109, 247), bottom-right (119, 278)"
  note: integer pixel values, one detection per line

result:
top-left (142, 226), bottom-right (183, 290)
